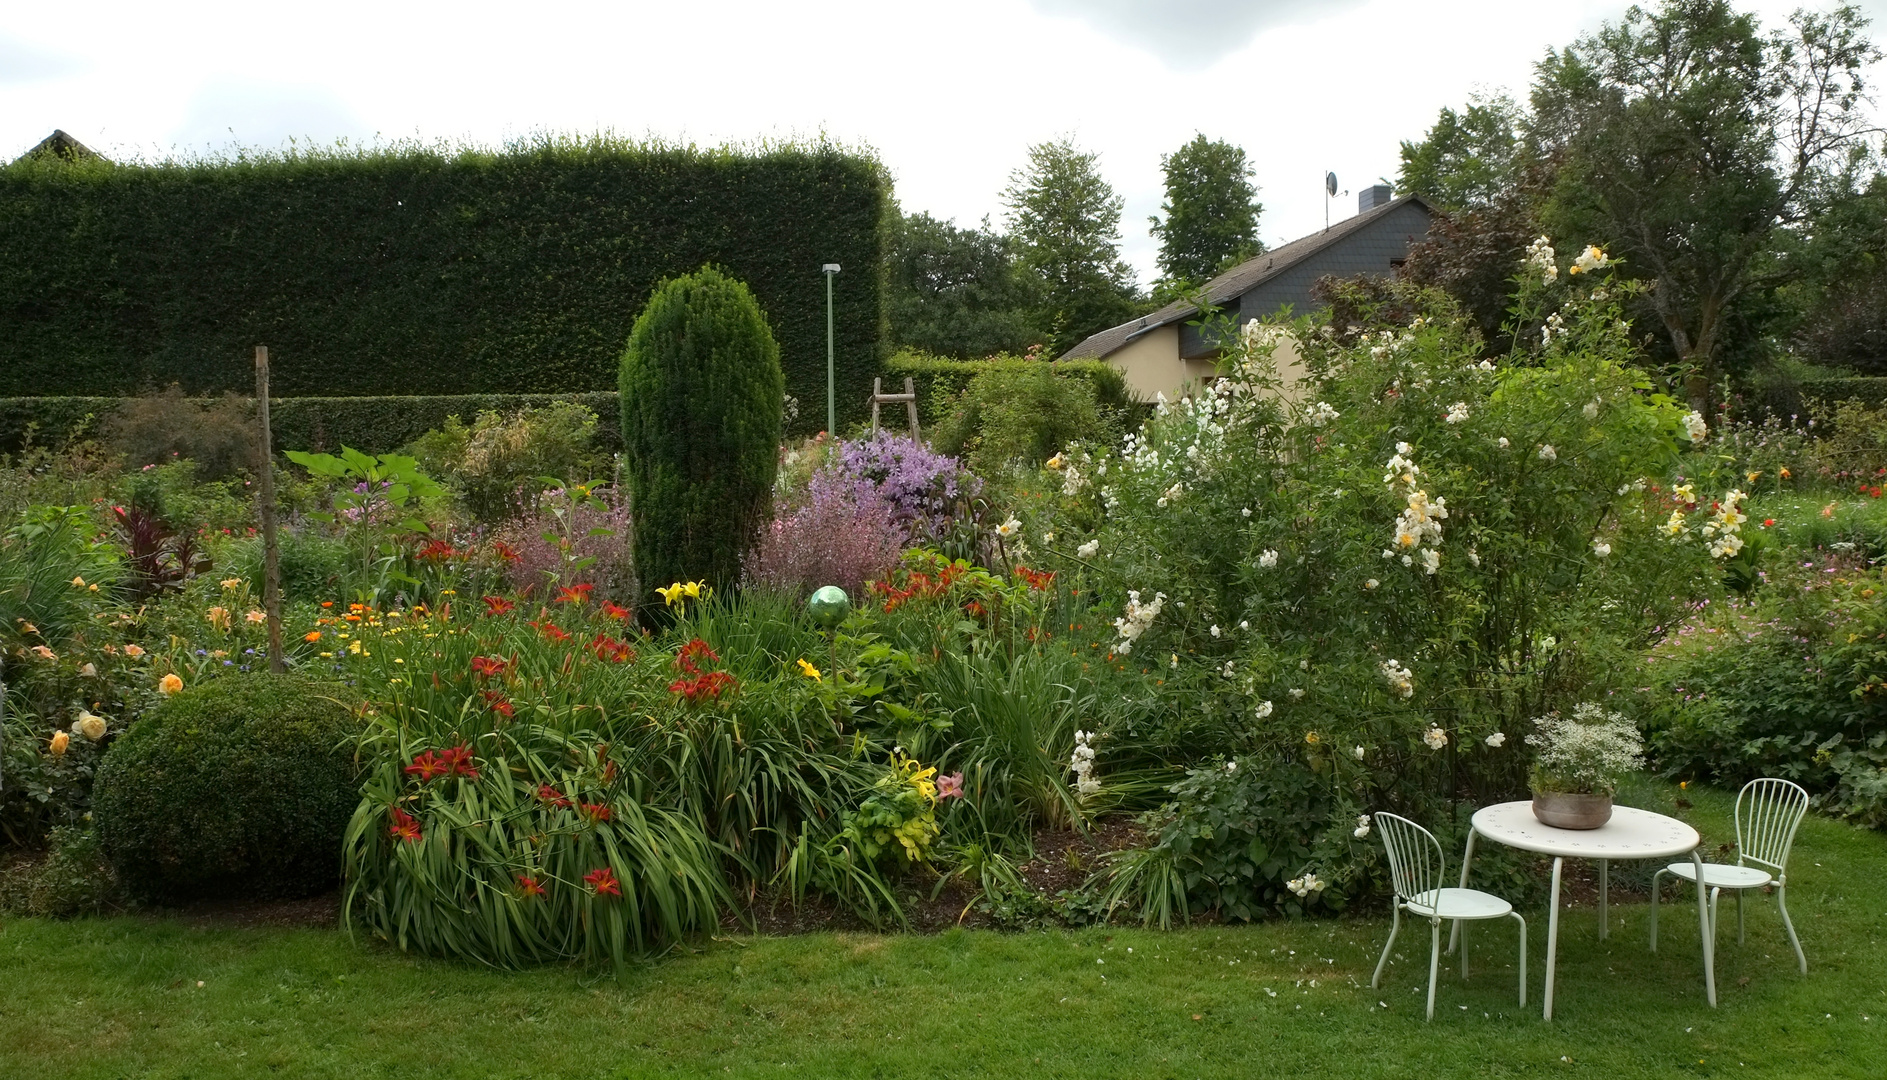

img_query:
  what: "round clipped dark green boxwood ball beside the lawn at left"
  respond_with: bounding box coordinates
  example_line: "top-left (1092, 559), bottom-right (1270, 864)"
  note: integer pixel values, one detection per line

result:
top-left (94, 674), bottom-right (359, 899)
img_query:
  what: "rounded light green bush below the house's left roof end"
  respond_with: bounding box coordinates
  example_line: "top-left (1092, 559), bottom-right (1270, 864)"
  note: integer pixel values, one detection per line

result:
top-left (930, 361), bottom-right (1113, 476)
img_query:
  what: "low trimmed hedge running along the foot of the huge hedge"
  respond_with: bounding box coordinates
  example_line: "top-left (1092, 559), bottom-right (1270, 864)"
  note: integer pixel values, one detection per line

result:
top-left (0, 391), bottom-right (623, 453)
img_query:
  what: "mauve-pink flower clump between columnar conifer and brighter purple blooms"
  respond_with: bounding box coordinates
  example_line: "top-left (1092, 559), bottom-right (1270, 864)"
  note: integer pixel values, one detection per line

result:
top-left (742, 474), bottom-right (906, 597)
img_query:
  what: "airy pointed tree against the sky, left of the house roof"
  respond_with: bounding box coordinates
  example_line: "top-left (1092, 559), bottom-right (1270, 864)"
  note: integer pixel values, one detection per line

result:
top-left (1002, 140), bottom-right (1138, 353)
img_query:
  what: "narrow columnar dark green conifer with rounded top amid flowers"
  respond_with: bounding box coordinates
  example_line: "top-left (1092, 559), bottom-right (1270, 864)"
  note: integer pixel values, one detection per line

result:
top-left (617, 266), bottom-right (785, 610)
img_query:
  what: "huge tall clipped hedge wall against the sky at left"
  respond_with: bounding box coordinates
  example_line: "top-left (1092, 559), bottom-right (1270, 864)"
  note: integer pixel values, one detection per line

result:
top-left (0, 140), bottom-right (889, 430)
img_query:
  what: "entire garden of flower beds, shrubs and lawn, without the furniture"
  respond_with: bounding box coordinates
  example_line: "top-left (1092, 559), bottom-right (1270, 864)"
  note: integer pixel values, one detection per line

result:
top-left (0, 238), bottom-right (1887, 1076)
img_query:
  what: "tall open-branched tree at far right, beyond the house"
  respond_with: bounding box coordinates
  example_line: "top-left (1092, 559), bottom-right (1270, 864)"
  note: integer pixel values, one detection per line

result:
top-left (1530, 0), bottom-right (1879, 404)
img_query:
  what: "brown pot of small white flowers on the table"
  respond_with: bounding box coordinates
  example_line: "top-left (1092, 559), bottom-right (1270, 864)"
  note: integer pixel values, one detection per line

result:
top-left (1527, 702), bottom-right (1644, 829)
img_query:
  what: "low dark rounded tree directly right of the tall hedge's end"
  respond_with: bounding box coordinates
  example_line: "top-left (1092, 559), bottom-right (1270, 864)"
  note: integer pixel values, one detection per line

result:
top-left (885, 213), bottom-right (1045, 359)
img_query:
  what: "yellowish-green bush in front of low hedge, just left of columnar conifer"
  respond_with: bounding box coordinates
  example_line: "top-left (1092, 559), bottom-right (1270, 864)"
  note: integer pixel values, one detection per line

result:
top-left (408, 402), bottom-right (602, 521)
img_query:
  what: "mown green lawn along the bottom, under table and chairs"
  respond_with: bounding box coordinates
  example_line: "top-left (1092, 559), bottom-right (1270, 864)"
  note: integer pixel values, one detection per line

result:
top-left (0, 785), bottom-right (1887, 1080)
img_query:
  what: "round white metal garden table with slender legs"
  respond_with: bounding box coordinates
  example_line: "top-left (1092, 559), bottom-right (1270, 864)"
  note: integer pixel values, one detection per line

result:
top-left (1447, 802), bottom-right (1717, 1020)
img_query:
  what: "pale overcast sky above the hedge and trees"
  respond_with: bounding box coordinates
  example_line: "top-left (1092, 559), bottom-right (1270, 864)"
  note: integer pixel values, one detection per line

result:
top-left (0, 0), bottom-right (1887, 285)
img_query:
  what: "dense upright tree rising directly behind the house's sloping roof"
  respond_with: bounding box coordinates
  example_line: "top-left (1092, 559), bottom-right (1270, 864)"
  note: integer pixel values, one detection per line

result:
top-left (1147, 134), bottom-right (1264, 287)
